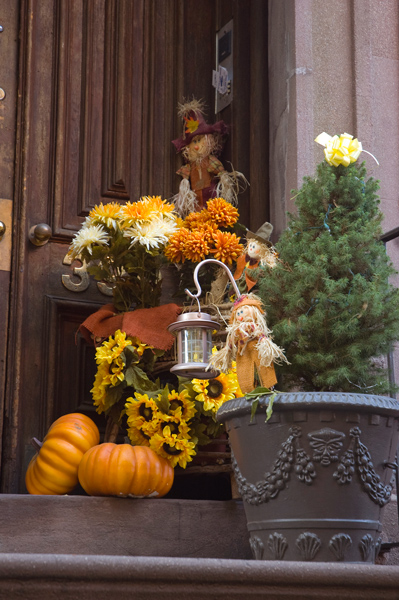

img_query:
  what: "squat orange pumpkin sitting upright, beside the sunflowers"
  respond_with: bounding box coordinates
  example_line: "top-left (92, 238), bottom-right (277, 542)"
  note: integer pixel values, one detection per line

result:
top-left (79, 443), bottom-right (174, 498)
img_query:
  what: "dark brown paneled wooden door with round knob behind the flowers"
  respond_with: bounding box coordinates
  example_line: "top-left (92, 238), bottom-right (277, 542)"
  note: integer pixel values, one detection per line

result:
top-left (0, 0), bottom-right (268, 493)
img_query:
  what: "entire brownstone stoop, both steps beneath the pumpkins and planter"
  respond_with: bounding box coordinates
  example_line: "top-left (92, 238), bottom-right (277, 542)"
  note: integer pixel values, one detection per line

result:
top-left (0, 494), bottom-right (399, 600)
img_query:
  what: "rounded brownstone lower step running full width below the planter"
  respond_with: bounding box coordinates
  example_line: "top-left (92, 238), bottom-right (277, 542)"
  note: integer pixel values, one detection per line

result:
top-left (0, 554), bottom-right (399, 600)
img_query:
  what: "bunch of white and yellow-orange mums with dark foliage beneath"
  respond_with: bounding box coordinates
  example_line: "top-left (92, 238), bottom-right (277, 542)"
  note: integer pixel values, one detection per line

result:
top-left (69, 196), bottom-right (178, 311)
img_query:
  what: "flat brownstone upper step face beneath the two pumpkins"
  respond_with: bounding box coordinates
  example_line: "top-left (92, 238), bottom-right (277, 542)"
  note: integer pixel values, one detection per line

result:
top-left (0, 494), bottom-right (252, 559)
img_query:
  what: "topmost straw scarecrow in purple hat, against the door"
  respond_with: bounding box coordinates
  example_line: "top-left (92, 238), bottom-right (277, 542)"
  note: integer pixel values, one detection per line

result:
top-left (172, 99), bottom-right (247, 218)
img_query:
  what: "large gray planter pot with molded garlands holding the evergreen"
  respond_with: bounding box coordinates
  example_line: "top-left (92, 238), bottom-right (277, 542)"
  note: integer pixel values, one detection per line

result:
top-left (217, 392), bottom-right (399, 563)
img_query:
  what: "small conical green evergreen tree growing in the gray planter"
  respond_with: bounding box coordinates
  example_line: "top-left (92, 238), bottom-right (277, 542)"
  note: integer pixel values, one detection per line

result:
top-left (259, 162), bottom-right (399, 394)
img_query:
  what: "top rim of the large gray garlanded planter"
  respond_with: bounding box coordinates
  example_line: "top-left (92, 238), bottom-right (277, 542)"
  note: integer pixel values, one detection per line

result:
top-left (216, 392), bottom-right (399, 423)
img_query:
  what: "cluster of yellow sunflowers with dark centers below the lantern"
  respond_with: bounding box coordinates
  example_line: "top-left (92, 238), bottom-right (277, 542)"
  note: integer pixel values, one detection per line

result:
top-left (91, 330), bottom-right (241, 468)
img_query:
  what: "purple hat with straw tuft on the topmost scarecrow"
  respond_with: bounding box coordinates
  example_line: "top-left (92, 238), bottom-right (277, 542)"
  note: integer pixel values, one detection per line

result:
top-left (172, 98), bottom-right (229, 152)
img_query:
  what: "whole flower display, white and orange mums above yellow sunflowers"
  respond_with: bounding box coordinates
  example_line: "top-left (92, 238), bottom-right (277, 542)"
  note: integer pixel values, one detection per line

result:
top-left (69, 196), bottom-right (248, 468)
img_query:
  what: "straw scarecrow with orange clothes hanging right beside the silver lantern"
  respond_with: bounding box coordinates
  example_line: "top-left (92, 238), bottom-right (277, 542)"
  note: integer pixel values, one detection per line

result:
top-left (210, 294), bottom-right (288, 394)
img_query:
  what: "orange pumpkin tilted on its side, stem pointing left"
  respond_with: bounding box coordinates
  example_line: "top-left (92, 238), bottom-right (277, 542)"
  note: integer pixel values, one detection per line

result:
top-left (25, 413), bottom-right (100, 495)
